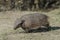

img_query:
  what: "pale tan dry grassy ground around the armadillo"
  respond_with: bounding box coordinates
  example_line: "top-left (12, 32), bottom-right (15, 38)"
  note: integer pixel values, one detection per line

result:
top-left (0, 9), bottom-right (60, 40)
